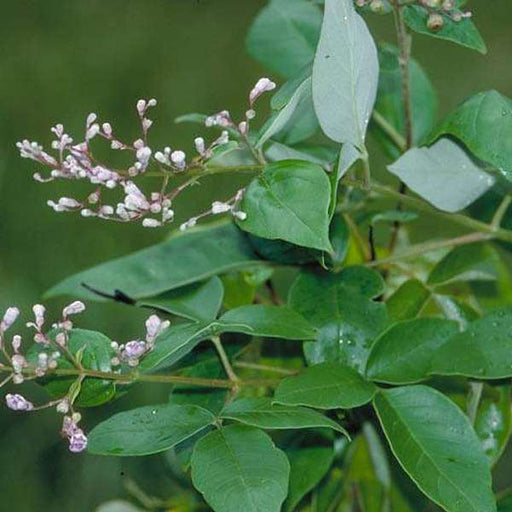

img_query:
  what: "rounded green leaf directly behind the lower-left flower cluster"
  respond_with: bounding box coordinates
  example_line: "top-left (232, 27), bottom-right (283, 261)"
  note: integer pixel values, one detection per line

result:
top-left (27, 329), bottom-right (116, 407)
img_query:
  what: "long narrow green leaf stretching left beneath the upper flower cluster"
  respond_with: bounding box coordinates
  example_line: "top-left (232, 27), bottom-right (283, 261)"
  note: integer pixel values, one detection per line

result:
top-left (46, 224), bottom-right (261, 300)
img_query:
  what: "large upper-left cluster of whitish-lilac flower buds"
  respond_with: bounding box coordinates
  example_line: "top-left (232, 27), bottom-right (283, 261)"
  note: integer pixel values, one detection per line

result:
top-left (17, 78), bottom-right (276, 230)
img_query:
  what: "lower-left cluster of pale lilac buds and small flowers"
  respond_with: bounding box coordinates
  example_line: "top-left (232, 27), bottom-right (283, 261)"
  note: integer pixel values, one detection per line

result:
top-left (0, 301), bottom-right (169, 453)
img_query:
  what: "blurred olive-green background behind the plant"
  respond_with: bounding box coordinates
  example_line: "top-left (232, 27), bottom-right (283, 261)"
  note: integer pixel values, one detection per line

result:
top-left (0, 0), bottom-right (512, 512)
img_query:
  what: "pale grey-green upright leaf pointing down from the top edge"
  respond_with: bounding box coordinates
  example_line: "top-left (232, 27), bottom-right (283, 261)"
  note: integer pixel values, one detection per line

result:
top-left (313, 0), bottom-right (379, 146)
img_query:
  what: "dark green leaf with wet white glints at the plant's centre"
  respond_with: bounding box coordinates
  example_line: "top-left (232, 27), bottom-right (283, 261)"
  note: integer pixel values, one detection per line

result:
top-left (289, 267), bottom-right (388, 371)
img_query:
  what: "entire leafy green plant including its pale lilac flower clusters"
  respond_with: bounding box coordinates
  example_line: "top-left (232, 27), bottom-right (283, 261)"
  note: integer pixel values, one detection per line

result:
top-left (0, 0), bottom-right (512, 512)
